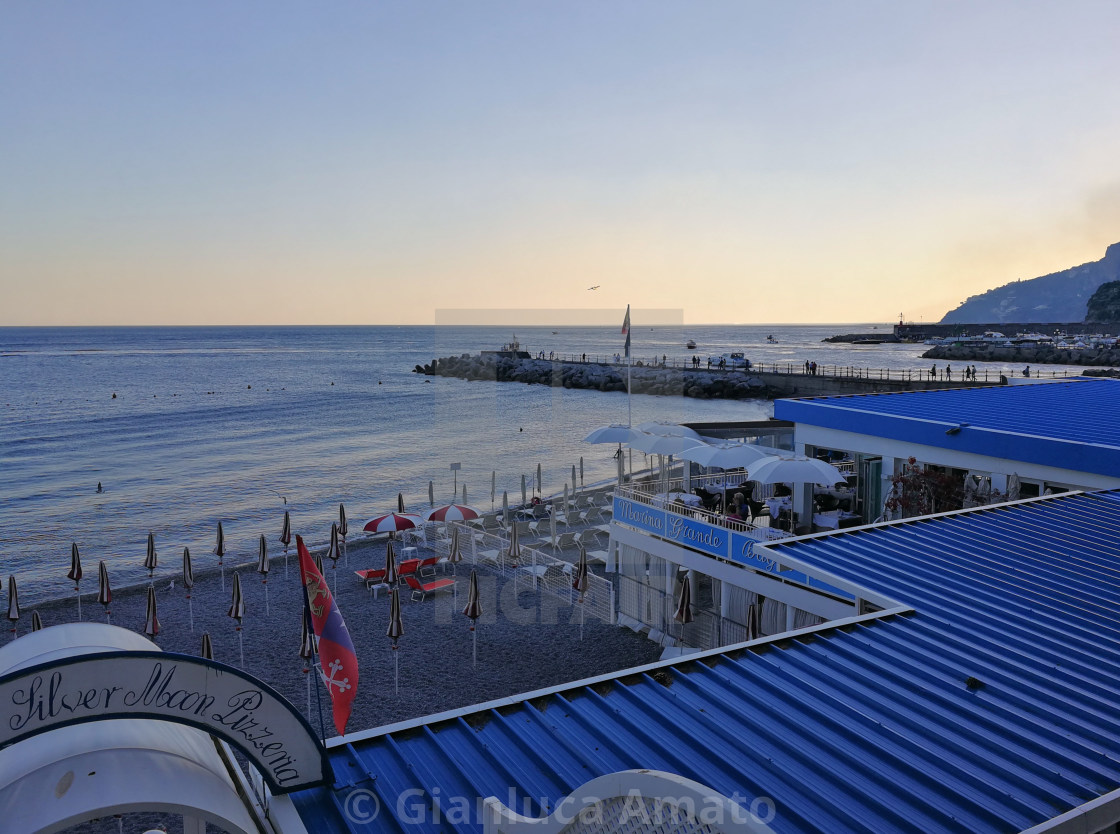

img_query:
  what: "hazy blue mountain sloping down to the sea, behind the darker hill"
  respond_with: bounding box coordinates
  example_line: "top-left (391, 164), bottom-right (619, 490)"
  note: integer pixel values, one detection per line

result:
top-left (941, 243), bottom-right (1120, 325)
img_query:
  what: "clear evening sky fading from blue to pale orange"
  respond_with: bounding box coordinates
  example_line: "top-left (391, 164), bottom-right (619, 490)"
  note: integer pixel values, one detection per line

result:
top-left (0, 0), bottom-right (1120, 325)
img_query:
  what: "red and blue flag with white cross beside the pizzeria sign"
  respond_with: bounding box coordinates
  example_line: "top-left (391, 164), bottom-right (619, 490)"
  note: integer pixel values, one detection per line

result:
top-left (296, 536), bottom-right (357, 735)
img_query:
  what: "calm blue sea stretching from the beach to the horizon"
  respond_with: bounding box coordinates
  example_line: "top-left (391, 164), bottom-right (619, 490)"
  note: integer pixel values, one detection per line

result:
top-left (0, 322), bottom-right (1079, 606)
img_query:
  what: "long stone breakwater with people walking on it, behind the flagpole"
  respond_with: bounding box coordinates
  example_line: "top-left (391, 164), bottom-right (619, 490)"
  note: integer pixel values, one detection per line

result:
top-left (413, 354), bottom-right (981, 400)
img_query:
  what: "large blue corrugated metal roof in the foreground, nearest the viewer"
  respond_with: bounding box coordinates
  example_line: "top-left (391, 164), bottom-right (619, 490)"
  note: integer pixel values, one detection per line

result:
top-left (293, 493), bottom-right (1120, 832)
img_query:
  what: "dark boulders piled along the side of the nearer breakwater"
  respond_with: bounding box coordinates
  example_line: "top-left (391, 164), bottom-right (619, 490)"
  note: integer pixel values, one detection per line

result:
top-left (413, 354), bottom-right (780, 400)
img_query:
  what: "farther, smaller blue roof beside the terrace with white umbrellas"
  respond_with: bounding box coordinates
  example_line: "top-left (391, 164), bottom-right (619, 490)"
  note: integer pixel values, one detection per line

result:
top-left (774, 378), bottom-right (1120, 476)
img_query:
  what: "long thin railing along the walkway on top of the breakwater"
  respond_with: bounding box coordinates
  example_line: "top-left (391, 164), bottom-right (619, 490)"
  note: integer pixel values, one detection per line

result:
top-left (521, 352), bottom-right (1071, 383)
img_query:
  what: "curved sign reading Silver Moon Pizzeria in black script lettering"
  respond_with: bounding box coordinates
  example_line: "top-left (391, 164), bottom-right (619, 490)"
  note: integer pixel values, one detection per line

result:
top-left (0, 652), bottom-right (330, 794)
